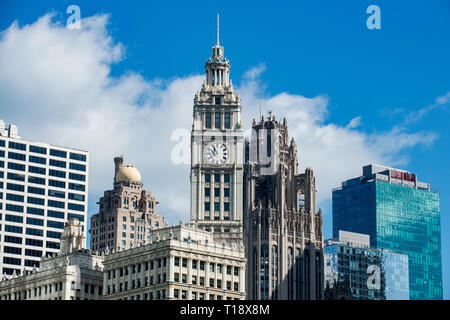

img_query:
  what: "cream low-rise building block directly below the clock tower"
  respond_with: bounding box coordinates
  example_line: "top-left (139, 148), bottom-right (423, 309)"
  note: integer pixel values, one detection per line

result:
top-left (103, 223), bottom-right (245, 300)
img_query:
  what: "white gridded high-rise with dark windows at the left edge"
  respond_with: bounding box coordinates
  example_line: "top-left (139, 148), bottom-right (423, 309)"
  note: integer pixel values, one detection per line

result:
top-left (0, 121), bottom-right (89, 275)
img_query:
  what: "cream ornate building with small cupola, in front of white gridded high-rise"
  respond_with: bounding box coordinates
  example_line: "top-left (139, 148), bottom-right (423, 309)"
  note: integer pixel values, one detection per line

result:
top-left (0, 219), bottom-right (103, 300)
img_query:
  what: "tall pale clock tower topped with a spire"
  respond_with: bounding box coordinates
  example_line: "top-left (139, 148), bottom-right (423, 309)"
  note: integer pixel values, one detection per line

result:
top-left (191, 16), bottom-right (244, 243)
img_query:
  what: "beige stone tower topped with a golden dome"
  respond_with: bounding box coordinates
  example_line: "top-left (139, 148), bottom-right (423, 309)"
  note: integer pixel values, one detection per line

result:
top-left (90, 157), bottom-right (167, 252)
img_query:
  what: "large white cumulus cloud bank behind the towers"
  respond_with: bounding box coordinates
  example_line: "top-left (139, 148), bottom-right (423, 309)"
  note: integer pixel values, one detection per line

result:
top-left (0, 14), bottom-right (436, 230)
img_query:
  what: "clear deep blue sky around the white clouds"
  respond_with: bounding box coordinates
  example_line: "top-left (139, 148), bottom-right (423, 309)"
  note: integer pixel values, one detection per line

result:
top-left (0, 0), bottom-right (450, 299)
